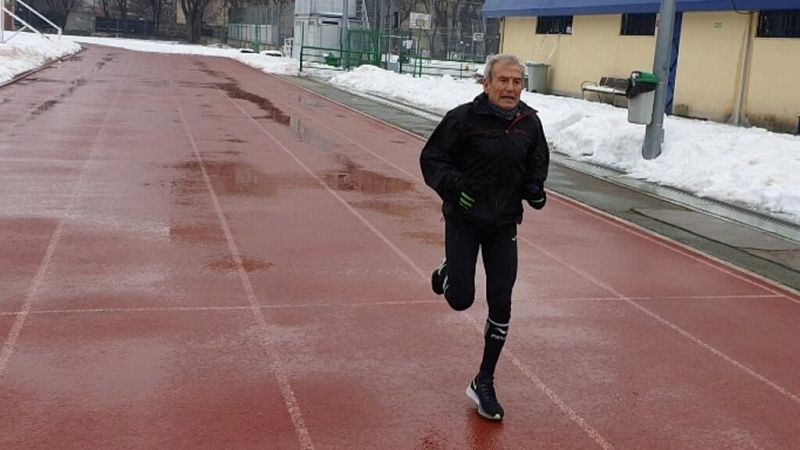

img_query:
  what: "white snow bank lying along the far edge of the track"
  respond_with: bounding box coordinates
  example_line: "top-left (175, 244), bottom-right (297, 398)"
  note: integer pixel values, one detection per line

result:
top-left (0, 33), bottom-right (800, 223)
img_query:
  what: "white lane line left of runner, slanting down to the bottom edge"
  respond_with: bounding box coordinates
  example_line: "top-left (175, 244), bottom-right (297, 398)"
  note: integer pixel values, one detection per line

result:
top-left (170, 59), bottom-right (314, 449)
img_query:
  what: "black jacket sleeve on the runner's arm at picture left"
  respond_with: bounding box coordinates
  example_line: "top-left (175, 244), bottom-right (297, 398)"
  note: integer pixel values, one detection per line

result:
top-left (419, 111), bottom-right (461, 201)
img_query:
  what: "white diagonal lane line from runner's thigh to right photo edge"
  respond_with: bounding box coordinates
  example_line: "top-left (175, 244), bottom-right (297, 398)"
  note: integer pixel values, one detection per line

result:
top-left (521, 234), bottom-right (800, 404)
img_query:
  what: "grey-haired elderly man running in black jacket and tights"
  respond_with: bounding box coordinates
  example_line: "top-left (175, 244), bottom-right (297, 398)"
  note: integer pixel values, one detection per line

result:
top-left (420, 54), bottom-right (550, 420)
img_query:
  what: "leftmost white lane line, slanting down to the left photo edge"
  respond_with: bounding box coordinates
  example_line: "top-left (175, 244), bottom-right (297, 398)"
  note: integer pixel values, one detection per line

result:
top-left (0, 76), bottom-right (127, 382)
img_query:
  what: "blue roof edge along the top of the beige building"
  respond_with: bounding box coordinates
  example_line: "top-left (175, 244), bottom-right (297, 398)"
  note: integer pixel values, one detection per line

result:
top-left (481, 0), bottom-right (800, 17)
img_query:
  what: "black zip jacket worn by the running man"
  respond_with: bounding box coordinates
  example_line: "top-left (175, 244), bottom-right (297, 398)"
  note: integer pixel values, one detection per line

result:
top-left (420, 94), bottom-right (550, 226)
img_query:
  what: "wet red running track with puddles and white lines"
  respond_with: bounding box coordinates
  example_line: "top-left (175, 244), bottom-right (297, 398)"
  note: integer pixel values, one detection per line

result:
top-left (0, 47), bottom-right (800, 449)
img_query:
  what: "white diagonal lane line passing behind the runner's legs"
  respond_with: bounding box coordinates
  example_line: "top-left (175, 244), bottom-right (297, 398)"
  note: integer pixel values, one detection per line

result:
top-left (206, 73), bottom-right (614, 450)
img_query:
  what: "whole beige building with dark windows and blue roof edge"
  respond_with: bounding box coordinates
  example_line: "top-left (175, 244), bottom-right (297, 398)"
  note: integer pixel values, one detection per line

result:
top-left (483, 0), bottom-right (800, 132)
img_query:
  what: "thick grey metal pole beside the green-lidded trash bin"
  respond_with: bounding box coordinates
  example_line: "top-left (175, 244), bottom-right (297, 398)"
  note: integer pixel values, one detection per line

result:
top-left (642, 0), bottom-right (676, 159)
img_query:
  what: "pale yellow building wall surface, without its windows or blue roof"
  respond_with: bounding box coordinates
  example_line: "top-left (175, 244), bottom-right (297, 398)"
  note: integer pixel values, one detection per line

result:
top-left (500, 11), bottom-right (800, 132)
